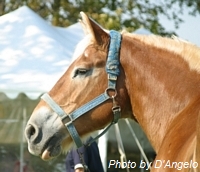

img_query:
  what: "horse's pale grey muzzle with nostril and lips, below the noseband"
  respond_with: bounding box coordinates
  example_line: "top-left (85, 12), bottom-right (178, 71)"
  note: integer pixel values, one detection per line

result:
top-left (25, 107), bottom-right (67, 160)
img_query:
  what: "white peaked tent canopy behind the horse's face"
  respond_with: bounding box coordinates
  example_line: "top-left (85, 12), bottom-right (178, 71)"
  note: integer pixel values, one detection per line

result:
top-left (0, 6), bottom-right (84, 98)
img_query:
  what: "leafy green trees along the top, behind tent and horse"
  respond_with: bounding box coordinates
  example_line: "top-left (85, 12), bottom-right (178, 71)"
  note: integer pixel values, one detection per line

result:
top-left (0, 0), bottom-right (200, 35)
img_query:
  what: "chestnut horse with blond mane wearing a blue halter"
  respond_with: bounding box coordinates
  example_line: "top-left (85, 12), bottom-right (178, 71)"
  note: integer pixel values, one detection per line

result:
top-left (25, 12), bottom-right (200, 172)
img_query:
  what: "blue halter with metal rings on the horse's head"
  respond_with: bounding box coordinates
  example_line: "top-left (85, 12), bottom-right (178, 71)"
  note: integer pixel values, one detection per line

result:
top-left (41, 30), bottom-right (121, 148)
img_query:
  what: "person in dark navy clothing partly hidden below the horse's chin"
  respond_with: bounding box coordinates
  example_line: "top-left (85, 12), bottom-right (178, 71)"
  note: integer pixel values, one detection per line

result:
top-left (66, 138), bottom-right (104, 172)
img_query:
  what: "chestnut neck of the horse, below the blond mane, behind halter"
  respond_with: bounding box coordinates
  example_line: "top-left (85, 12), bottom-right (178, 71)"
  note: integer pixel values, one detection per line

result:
top-left (120, 36), bottom-right (200, 151)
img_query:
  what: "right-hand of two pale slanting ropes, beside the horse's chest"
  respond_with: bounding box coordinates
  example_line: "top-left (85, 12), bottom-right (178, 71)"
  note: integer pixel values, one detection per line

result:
top-left (125, 119), bottom-right (151, 170)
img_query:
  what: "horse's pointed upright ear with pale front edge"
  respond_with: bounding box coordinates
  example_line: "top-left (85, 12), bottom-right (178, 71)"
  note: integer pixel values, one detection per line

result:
top-left (80, 12), bottom-right (109, 45)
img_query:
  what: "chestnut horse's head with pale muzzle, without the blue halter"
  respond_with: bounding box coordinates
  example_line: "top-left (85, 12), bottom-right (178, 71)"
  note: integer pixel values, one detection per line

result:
top-left (25, 12), bottom-right (130, 160)
